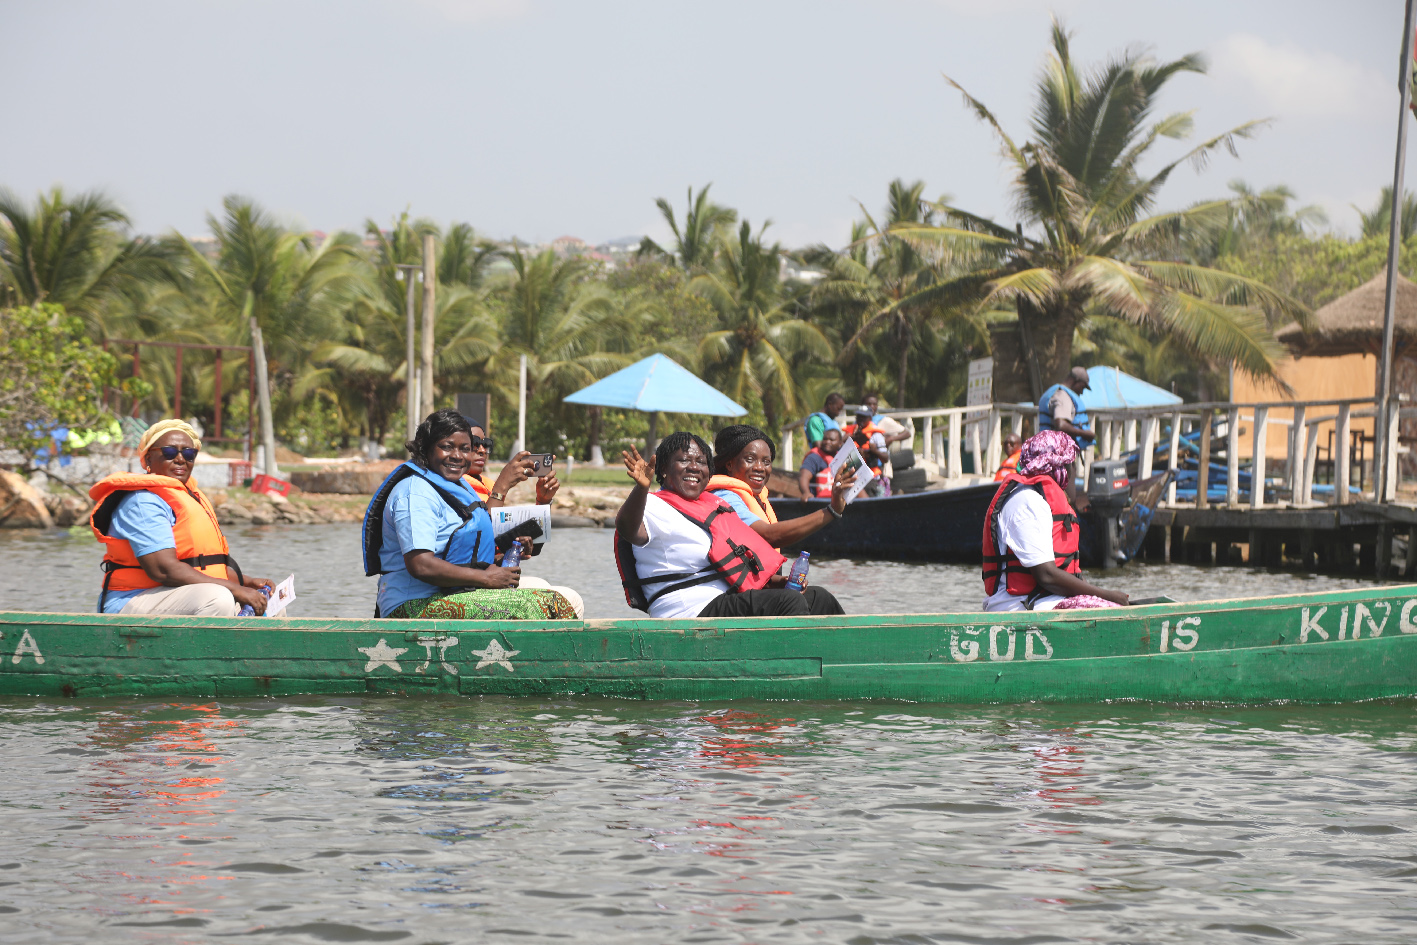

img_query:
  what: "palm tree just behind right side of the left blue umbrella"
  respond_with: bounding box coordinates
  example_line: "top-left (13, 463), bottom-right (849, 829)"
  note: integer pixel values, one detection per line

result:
top-left (693, 220), bottom-right (832, 428)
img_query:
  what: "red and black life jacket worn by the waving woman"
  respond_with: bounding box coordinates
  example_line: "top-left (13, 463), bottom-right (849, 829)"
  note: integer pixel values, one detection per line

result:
top-left (615, 489), bottom-right (786, 612)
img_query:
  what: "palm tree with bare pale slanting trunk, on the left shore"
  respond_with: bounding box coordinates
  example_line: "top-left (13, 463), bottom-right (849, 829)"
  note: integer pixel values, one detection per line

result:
top-left (183, 197), bottom-right (359, 476)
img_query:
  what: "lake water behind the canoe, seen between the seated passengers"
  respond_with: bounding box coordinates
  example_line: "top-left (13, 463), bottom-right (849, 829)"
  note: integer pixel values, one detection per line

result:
top-left (0, 524), bottom-right (1372, 618)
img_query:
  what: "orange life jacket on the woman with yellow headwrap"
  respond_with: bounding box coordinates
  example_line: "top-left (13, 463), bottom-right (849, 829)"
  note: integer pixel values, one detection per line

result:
top-left (89, 473), bottom-right (242, 613)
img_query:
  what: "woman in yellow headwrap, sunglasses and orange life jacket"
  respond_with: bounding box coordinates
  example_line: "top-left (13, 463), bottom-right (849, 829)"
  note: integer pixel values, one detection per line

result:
top-left (89, 419), bottom-right (271, 616)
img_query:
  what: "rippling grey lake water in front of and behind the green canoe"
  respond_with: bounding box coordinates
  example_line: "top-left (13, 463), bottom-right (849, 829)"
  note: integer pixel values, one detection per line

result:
top-left (0, 526), bottom-right (1417, 945)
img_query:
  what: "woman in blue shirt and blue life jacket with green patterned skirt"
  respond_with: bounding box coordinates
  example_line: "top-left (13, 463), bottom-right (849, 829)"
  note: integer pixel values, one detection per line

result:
top-left (363, 409), bottom-right (580, 621)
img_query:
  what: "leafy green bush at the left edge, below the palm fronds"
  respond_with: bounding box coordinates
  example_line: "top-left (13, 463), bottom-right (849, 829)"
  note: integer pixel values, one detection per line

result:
top-left (0, 303), bottom-right (115, 463)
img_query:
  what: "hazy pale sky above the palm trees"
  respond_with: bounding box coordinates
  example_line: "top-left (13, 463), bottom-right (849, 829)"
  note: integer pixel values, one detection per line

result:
top-left (0, 0), bottom-right (1411, 245)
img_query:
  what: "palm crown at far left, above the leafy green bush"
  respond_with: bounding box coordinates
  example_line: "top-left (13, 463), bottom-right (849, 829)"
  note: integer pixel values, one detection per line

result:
top-left (0, 187), bottom-right (171, 332)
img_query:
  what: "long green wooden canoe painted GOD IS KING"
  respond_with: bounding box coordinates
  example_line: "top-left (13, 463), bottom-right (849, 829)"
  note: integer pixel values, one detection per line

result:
top-left (0, 585), bottom-right (1417, 703)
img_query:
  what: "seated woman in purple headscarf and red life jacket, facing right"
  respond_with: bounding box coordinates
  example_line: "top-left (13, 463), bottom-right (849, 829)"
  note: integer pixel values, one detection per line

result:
top-left (983, 429), bottom-right (1128, 611)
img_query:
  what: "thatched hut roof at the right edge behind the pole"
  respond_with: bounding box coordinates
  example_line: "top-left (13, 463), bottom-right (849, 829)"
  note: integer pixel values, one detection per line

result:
top-left (1275, 269), bottom-right (1417, 357)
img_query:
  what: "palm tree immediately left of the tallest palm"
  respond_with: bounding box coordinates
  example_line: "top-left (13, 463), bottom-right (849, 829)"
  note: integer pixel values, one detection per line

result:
top-left (811, 179), bottom-right (985, 405)
